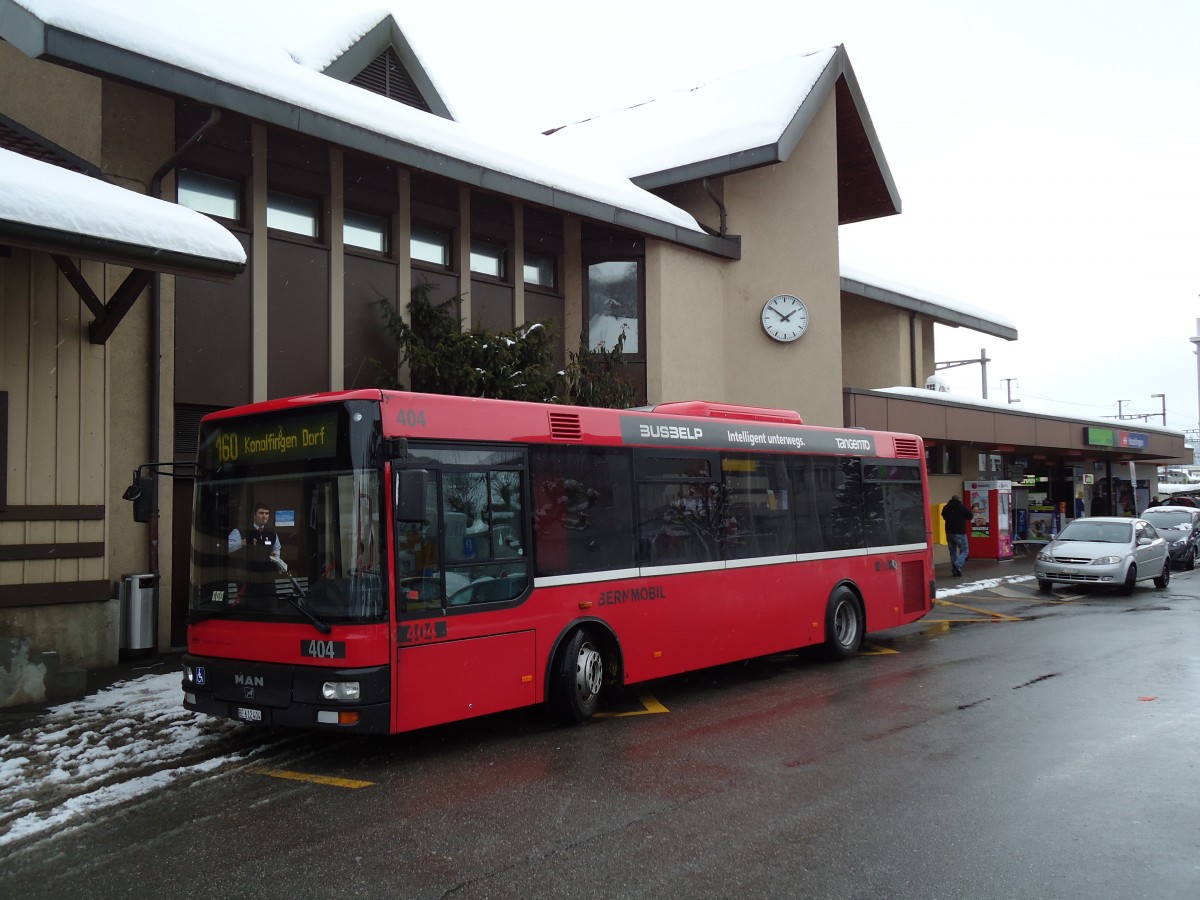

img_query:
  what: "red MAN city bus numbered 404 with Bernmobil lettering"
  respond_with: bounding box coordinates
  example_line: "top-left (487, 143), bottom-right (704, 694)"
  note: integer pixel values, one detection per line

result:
top-left (184, 390), bottom-right (935, 733)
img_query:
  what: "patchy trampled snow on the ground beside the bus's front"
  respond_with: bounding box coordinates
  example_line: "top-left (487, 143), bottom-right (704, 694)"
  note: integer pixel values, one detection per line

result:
top-left (0, 672), bottom-right (248, 851)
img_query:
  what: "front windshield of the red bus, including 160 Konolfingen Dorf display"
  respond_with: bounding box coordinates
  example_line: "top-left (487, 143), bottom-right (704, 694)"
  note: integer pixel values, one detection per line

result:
top-left (190, 406), bottom-right (388, 628)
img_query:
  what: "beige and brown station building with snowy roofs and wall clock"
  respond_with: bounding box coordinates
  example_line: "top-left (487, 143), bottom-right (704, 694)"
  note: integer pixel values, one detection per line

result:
top-left (0, 0), bottom-right (1184, 706)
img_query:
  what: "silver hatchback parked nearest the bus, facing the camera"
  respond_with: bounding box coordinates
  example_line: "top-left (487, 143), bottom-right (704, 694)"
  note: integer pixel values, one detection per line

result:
top-left (1033, 516), bottom-right (1171, 594)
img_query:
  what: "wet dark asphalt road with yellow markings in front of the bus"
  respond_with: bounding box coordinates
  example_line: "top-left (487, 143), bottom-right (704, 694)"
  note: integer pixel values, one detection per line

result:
top-left (0, 572), bottom-right (1200, 900)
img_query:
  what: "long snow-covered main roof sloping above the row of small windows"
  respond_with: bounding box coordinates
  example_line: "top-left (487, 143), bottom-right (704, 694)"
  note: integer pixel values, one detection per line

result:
top-left (0, 0), bottom-right (738, 257)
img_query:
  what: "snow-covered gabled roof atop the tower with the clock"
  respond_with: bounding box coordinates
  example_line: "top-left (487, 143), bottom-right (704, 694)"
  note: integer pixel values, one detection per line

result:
top-left (550, 47), bottom-right (900, 223)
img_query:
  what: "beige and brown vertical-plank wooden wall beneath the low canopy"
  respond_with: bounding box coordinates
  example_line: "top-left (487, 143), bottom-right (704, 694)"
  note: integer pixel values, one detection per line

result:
top-left (0, 250), bottom-right (110, 607)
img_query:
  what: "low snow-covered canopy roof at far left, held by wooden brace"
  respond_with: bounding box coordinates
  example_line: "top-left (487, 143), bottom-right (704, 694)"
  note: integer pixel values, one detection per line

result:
top-left (0, 149), bottom-right (246, 276)
